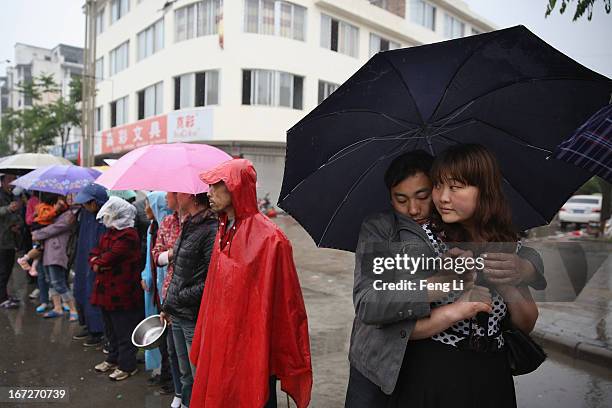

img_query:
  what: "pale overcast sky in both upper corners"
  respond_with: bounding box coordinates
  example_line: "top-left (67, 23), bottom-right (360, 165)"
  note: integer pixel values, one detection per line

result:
top-left (0, 0), bottom-right (612, 77)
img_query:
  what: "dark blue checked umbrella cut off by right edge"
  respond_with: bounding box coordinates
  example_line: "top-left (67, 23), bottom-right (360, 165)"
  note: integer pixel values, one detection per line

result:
top-left (554, 104), bottom-right (612, 183)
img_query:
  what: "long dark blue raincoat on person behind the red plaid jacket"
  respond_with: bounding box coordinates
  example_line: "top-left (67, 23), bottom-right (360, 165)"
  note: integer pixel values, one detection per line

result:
top-left (74, 186), bottom-right (108, 333)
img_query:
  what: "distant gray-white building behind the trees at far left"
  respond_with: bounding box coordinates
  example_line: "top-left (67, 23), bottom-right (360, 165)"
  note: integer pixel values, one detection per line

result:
top-left (6, 43), bottom-right (83, 160)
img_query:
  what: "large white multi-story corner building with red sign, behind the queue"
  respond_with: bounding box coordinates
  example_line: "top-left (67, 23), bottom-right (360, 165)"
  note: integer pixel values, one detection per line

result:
top-left (95, 0), bottom-right (493, 202)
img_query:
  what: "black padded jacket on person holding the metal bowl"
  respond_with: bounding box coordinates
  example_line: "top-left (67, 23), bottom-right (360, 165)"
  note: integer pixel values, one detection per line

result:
top-left (163, 210), bottom-right (218, 322)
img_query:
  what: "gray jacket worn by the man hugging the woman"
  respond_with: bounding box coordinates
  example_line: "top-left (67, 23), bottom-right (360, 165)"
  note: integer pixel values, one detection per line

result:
top-left (349, 210), bottom-right (544, 394)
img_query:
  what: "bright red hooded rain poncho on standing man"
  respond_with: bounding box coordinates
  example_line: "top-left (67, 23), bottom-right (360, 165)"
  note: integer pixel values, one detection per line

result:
top-left (190, 159), bottom-right (312, 408)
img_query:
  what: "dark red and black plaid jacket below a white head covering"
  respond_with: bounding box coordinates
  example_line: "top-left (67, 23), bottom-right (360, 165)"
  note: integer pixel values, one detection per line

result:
top-left (89, 228), bottom-right (143, 310)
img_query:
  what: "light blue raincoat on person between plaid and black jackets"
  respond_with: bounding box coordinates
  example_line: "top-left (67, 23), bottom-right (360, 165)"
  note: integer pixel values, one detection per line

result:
top-left (141, 191), bottom-right (172, 370)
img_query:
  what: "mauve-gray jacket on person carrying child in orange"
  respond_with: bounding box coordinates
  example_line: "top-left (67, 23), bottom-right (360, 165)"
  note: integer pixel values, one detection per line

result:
top-left (32, 210), bottom-right (76, 269)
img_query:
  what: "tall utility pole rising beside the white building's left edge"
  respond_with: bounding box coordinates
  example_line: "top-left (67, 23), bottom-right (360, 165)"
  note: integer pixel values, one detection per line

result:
top-left (81, 0), bottom-right (97, 167)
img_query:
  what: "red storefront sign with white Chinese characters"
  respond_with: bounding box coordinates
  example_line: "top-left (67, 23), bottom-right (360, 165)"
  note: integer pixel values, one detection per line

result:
top-left (102, 115), bottom-right (168, 154)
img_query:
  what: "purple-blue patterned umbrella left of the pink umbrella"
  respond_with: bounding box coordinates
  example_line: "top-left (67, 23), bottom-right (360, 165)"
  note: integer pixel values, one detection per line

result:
top-left (12, 165), bottom-right (102, 195)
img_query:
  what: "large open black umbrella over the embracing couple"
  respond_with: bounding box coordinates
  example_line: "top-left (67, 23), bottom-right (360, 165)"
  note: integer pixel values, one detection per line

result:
top-left (279, 26), bottom-right (612, 251)
